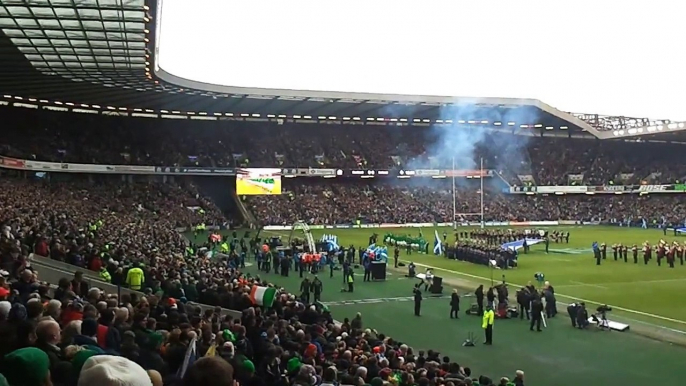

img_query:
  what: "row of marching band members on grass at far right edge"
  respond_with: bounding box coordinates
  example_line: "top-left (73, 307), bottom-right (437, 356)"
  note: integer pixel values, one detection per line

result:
top-left (593, 240), bottom-right (686, 268)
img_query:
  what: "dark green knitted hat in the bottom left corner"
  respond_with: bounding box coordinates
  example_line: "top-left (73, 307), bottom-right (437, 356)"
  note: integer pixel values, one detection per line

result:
top-left (2, 347), bottom-right (50, 386)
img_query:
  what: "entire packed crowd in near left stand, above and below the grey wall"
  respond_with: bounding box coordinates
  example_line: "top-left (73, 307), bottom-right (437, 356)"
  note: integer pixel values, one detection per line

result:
top-left (0, 178), bottom-right (524, 386)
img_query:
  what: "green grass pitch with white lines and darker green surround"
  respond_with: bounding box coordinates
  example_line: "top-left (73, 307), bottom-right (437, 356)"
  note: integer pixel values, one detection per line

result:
top-left (187, 226), bottom-right (686, 385)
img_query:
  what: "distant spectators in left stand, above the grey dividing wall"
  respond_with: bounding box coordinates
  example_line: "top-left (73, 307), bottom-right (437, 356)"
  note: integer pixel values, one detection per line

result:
top-left (0, 177), bottom-right (226, 285)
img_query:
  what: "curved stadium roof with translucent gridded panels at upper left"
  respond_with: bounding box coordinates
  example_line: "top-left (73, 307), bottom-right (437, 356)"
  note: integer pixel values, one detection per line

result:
top-left (0, 0), bottom-right (684, 142)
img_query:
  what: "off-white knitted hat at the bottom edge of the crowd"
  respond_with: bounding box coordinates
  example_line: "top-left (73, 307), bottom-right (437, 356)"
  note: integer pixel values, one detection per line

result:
top-left (78, 355), bottom-right (152, 386)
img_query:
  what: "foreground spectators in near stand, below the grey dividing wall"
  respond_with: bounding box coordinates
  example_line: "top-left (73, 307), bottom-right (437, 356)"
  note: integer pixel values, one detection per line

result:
top-left (0, 270), bottom-right (524, 386)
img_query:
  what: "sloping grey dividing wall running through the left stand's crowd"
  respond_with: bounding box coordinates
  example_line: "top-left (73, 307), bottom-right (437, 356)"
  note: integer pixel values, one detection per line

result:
top-left (29, 254), bottom-right (242, 319)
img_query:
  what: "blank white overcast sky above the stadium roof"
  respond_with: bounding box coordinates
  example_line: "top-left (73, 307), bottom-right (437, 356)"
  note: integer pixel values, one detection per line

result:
top-left (157, 0), bottom-right (686, 120)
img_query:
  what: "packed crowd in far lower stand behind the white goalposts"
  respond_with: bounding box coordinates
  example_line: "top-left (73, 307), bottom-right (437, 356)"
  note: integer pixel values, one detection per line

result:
top-left (246, 180), bottom-right (686, 225)
